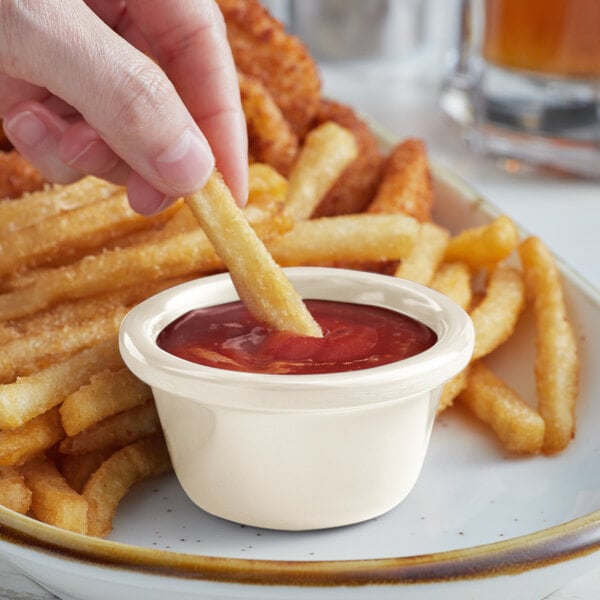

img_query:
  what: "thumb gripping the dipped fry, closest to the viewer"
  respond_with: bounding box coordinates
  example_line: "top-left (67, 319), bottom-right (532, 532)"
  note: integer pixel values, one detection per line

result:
top-left (0, 0), bottom-right (214, 207)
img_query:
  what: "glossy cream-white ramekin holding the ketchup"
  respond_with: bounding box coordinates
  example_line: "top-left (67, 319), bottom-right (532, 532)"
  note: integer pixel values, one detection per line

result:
top-left (120, 267), bottom-right (473, 530)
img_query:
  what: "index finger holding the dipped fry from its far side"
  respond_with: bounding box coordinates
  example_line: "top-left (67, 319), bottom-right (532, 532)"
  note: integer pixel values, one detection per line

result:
top-left (127, 0), bottom-right (248, 204)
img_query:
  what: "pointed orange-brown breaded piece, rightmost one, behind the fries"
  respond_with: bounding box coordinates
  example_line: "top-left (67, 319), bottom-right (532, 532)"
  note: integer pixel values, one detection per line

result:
top-left (368, 138), bottom-right (433, 222)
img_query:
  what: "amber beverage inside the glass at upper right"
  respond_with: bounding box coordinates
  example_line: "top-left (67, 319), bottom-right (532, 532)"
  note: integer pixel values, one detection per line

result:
top-left (483, 0), bottom-right (600, 78)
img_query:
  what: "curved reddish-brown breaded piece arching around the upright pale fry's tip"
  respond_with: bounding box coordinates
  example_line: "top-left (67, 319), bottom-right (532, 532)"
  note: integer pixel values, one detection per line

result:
top-left (313, 99), bottom-right (383, 217)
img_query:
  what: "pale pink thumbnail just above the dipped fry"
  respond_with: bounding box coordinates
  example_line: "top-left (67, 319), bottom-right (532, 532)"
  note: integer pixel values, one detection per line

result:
top-left (155, 129), bottom-right (214, 192)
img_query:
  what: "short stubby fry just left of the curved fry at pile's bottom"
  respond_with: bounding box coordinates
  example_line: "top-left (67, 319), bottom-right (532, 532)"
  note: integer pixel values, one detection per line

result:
top-left (22, 456), bottom-right (88, 533)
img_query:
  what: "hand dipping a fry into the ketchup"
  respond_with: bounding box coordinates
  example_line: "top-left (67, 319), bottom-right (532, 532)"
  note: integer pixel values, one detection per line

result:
top-left (0, 0), bottom-right (248, 214)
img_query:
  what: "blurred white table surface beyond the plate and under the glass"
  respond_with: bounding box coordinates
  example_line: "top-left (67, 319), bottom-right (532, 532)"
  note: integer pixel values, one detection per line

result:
top-left (0, 57), bottom-right (600, 600)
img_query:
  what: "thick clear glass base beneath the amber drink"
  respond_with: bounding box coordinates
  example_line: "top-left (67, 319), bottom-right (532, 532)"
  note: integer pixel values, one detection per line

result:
top-left (440, 61), bottom-right (600, 178)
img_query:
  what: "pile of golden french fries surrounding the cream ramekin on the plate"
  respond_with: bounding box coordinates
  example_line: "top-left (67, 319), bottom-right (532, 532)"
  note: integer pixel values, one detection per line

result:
top-left (0, 0), bottom-right (579, 537)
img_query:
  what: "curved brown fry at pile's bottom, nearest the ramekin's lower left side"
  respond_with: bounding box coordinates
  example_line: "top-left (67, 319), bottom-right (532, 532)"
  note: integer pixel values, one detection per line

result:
top-left (82, 435), bottom-right (171, 537)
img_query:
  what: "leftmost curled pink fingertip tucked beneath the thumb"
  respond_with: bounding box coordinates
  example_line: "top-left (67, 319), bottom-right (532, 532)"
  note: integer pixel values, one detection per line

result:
top-left (2, 101), bottom-right (81, 183)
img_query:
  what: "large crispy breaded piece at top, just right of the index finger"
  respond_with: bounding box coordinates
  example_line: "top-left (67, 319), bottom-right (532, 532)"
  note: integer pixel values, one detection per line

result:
top-left (218, 0), bottom-right (321, 136)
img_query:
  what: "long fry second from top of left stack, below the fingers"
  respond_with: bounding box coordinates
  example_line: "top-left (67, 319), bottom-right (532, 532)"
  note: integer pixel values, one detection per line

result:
top-left (0, 190), bottom-right (178, 275)
